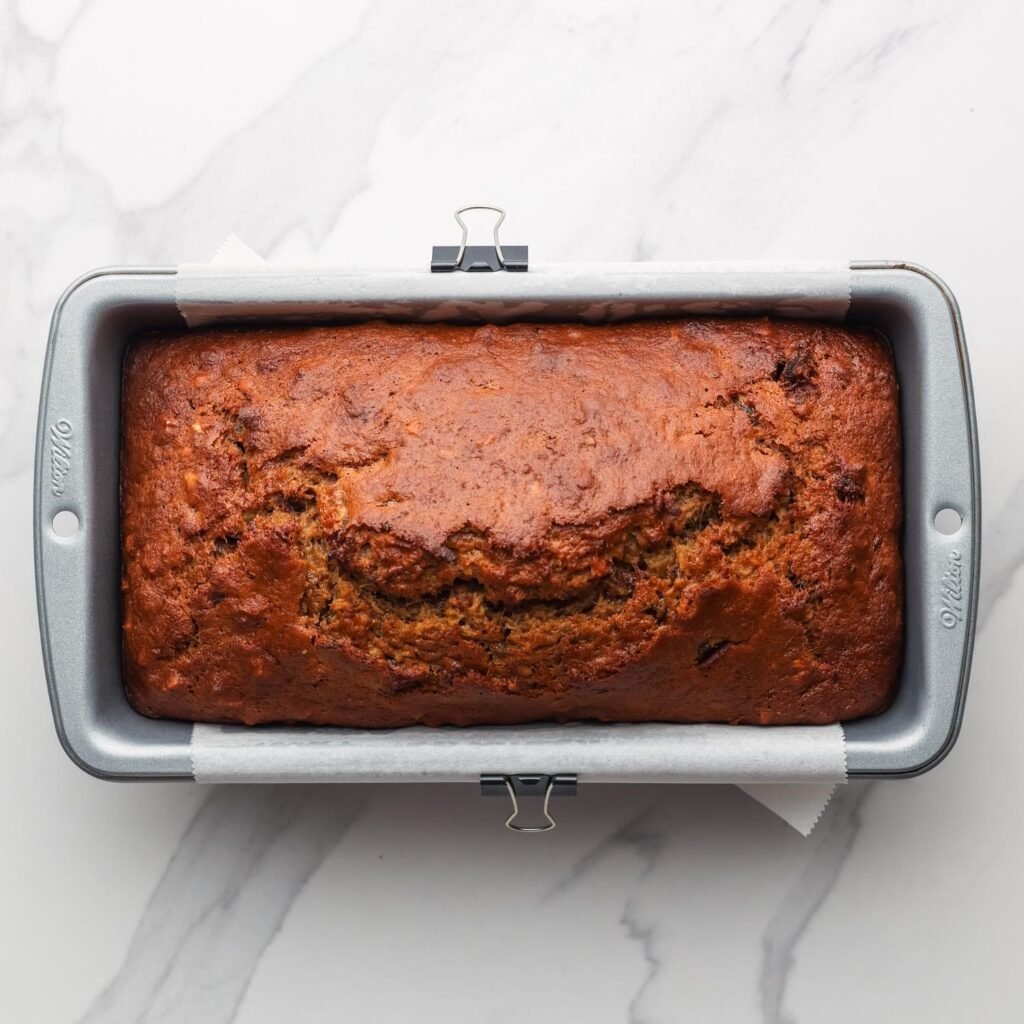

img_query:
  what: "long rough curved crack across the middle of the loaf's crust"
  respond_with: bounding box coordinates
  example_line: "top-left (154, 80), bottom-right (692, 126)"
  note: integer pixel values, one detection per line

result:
top-left (149, 450), bottom-right (794, 691)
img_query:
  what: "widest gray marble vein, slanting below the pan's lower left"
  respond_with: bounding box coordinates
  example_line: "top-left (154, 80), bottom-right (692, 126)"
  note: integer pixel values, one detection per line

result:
top-left (80, 785), bottom-right (362, 1024)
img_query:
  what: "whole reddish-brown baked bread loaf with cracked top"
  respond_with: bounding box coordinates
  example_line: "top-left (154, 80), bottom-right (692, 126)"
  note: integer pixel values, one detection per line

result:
top-left (121, 318), bottom-right (902, 727)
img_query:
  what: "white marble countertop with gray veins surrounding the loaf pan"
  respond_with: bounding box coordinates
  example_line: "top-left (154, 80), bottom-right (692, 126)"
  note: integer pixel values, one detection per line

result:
top-left (0, 0), bottom-right (1024, 1024)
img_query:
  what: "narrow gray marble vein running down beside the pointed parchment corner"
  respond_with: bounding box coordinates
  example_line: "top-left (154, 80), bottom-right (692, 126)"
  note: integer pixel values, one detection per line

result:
top-left (759, 782), bottom-right (876, 1024)
